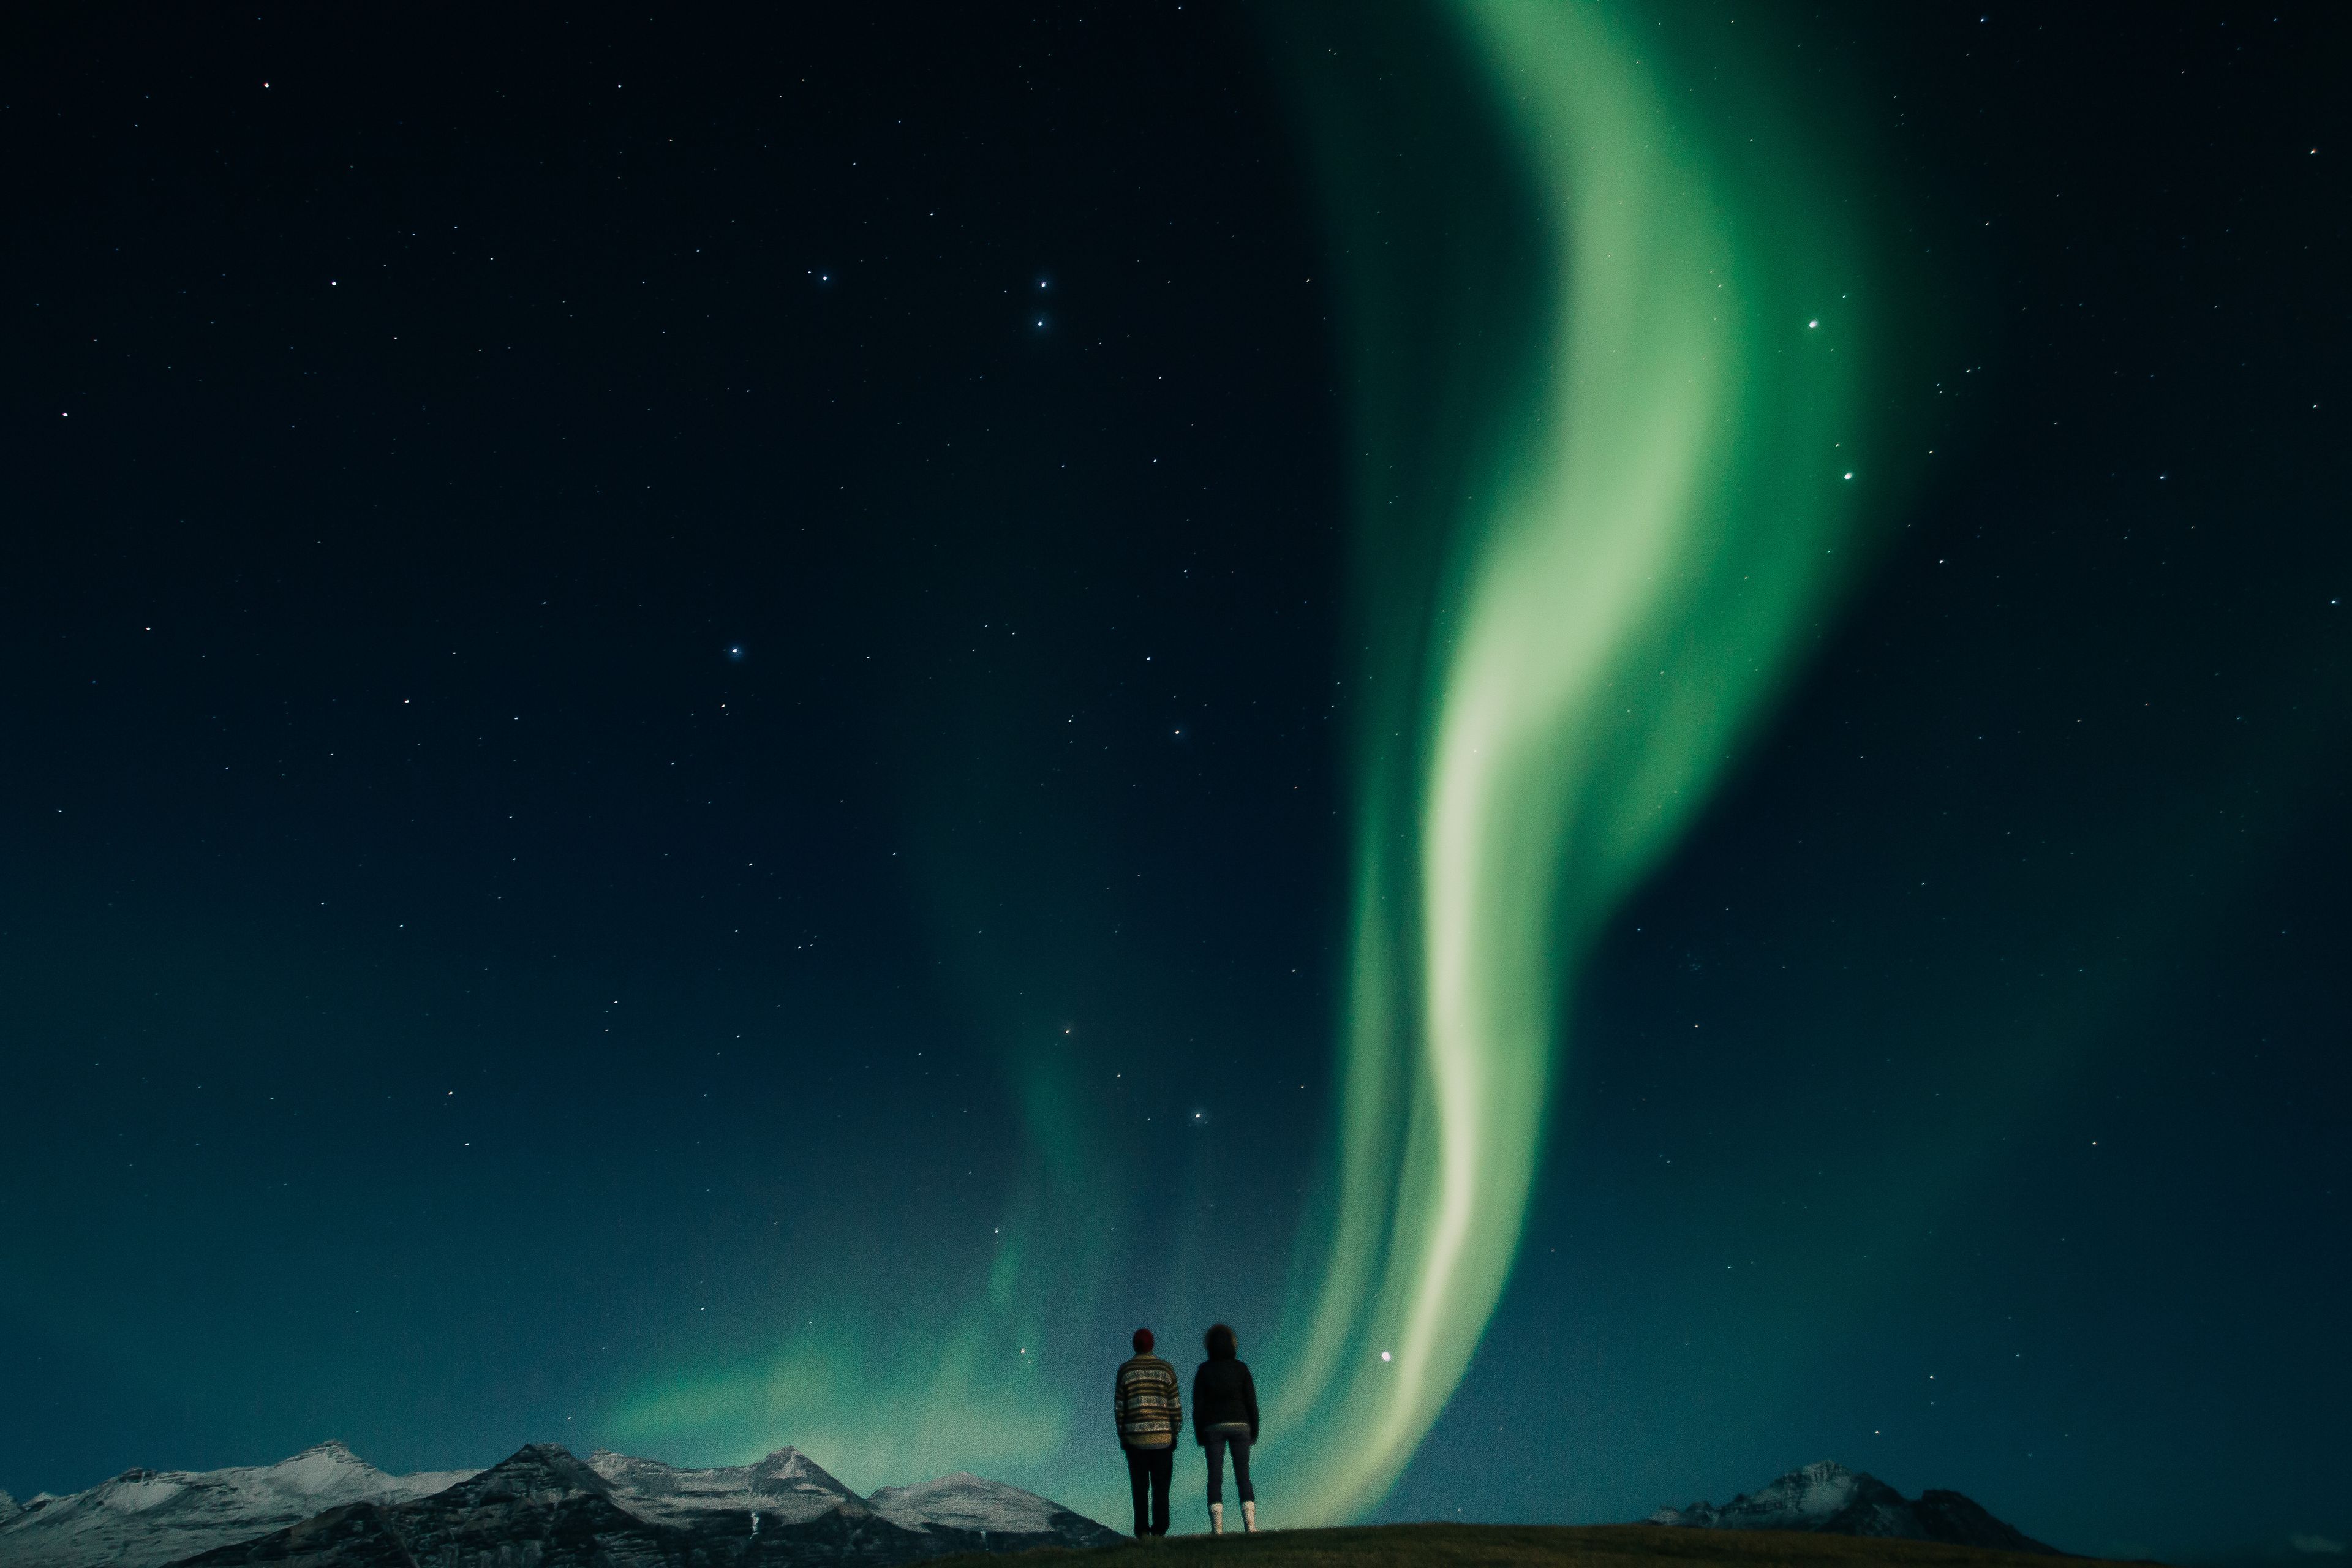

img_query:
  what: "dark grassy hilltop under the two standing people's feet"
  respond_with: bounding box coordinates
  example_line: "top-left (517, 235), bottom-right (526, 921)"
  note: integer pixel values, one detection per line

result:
top-left (933, 1523), bottom-right (2154, 1568)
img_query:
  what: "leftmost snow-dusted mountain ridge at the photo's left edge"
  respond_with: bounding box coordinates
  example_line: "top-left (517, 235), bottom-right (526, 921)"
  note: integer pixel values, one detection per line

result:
top-left (0, 1444), bottom-right (473, 1568)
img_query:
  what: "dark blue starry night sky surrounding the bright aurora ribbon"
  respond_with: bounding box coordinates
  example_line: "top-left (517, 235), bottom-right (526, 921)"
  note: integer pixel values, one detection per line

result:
top-left (0, 0), bottom-right (2352, 1561)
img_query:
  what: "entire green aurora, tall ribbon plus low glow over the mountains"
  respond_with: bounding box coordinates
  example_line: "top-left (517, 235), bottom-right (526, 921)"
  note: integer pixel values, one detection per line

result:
top-left (609, 0), bottom-right (1884, 1523)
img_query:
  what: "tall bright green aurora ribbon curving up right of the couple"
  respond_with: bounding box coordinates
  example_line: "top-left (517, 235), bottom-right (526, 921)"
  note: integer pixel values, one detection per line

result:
top-left (1270, 0), bottom-right (1860, 1518)
